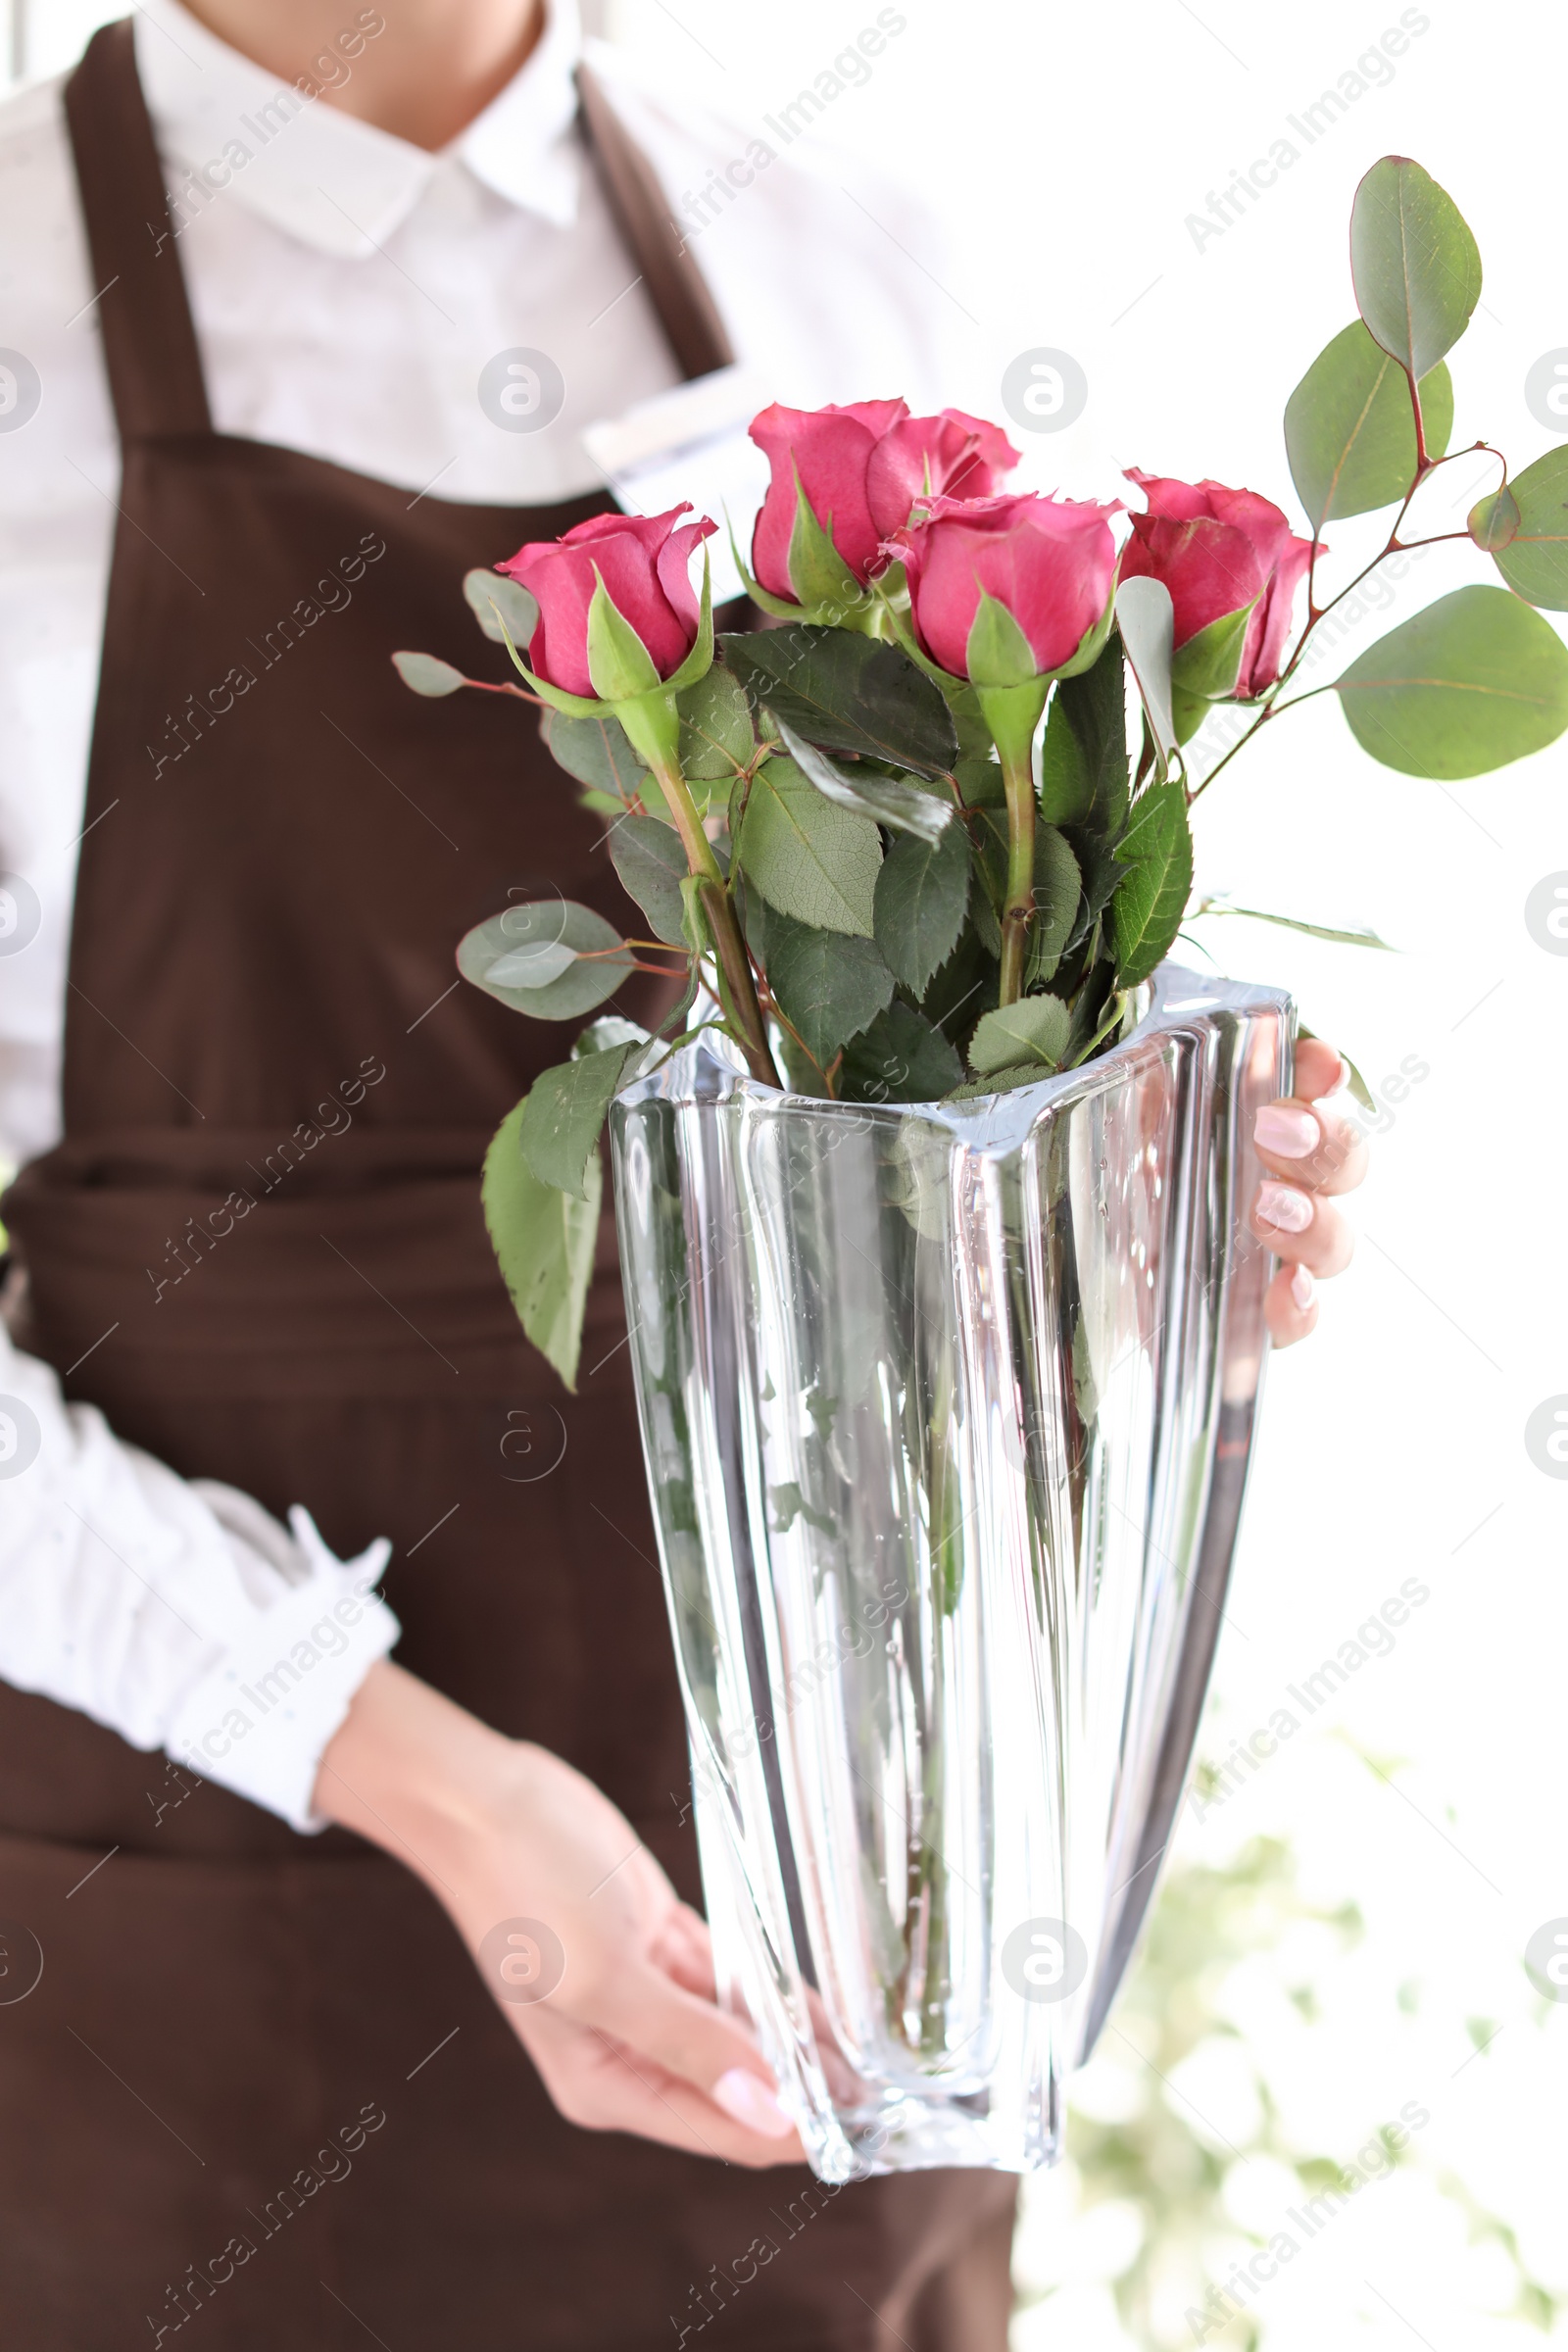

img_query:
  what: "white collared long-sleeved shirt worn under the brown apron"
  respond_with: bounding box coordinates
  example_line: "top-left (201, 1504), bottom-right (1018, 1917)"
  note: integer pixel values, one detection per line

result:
top-left (0, 0), bottom-right (956, 1828)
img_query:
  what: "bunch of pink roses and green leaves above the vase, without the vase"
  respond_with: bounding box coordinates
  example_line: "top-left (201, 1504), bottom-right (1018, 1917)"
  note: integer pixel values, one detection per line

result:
top-left (397, 155), bottom-right (1568, 1383)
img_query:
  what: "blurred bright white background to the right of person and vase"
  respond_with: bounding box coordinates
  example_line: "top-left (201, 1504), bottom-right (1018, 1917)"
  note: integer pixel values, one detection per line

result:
top-left (12, 0), bottom-right (1568, 2352)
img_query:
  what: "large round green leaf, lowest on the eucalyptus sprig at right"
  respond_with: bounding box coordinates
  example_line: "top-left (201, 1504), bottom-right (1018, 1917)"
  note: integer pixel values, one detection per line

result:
top-left (1336, 588), bottom-right (1568, 783)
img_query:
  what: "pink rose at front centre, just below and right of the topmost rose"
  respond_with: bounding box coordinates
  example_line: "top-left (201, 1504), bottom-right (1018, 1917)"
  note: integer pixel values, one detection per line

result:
top-left (889, 494), bottom-right (1116, 684)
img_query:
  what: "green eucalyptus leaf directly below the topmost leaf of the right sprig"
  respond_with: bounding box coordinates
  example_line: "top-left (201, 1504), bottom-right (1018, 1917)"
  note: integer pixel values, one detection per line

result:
top-left (1286, 318), bottom-right (1452, 524)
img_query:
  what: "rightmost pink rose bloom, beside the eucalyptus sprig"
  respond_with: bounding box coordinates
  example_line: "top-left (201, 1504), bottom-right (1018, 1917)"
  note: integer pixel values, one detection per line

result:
top-left (1121, 466), bottom-right (1312, 701)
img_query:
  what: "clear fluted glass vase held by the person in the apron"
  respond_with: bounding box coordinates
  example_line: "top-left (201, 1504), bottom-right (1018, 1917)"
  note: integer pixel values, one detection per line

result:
top-left (612, 964), bottom-right (1293, 2180)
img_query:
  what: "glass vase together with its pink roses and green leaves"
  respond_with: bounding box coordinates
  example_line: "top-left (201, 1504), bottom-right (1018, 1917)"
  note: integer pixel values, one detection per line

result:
top-left (397, 158), bottom-right (1568, 2180)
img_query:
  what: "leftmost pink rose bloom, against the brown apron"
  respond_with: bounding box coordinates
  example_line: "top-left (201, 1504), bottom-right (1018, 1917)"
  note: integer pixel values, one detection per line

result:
top-left (496, 501), bottom-right (717, 694)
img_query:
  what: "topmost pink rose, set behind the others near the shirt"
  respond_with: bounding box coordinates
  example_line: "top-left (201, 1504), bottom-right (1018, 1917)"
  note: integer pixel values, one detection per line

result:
top-left (750, 400), bottom-right (1018, 602)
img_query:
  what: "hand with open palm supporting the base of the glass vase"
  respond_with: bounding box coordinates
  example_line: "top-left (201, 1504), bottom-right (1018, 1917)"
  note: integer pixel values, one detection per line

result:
top-left (315, 1660), bottom-right (804, 2166)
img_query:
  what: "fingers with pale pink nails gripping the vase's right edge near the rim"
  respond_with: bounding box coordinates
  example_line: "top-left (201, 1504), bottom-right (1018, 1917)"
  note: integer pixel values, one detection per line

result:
top-left (1253, 1037), bottom-right (1366, 1348)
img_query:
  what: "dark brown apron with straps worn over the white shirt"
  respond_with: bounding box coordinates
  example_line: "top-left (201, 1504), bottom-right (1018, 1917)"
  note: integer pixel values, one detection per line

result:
top-left (0, 24), bottom-right (1013, 2352)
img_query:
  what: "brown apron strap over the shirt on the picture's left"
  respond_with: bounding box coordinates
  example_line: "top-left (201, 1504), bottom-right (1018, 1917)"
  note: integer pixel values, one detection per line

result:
top-left (66, 17), bottom-right (212, 442)
